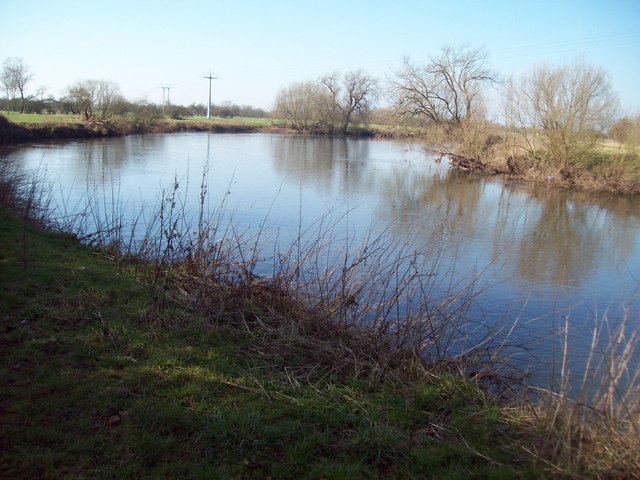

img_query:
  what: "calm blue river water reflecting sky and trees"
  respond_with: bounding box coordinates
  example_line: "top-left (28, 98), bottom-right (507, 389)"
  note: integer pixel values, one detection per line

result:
top-left (6, 133), bottom-right (640, 390)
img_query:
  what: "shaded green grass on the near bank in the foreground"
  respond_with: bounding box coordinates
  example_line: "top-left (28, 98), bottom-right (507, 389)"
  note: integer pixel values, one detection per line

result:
top-left (0, 210), bottom-right (541, 479)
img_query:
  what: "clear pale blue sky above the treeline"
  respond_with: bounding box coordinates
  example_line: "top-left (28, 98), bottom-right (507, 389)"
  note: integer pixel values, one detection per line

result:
top-left (0, 0), bottom-right (640, 114)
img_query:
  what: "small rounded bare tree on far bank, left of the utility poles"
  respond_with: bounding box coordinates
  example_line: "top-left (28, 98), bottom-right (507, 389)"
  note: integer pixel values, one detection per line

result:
top-left (65, 80), bottom-right (124, 122)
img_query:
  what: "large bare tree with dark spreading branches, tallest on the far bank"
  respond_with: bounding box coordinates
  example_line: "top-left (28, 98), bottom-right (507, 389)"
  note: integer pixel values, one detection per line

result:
top-left (390, 46), bottom-right (497, 125)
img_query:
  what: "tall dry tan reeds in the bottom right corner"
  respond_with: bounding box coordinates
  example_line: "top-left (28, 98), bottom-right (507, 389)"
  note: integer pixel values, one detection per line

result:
top-left (531, 304), bottom-right (640, 479)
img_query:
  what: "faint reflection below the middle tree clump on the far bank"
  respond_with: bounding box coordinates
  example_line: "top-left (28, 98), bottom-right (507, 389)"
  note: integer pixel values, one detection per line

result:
top-left (272, 136), bottom-right (373, 193)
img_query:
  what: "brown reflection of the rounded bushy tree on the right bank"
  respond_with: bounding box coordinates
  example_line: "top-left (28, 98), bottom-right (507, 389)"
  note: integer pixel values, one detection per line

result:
top-left (484, 185), bottom-right (637, 286)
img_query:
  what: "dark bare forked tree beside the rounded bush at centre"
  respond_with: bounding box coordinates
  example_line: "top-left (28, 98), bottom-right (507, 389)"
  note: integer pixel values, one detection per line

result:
top-left (320, 70), bottom-right (377, 133)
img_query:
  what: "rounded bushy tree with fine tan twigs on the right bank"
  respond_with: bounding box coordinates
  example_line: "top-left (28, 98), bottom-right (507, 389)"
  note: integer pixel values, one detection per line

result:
top-left (510, 62), bottom-right (618, 168)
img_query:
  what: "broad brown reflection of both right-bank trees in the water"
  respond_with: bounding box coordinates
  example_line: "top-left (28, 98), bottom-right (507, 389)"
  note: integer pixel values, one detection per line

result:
top-left (379, 168), bottom-right (638, 286)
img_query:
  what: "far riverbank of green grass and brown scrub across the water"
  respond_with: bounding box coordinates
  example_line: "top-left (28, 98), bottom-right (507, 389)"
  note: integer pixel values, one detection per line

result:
top-left (0, 114), bottom-right (640, 195)
